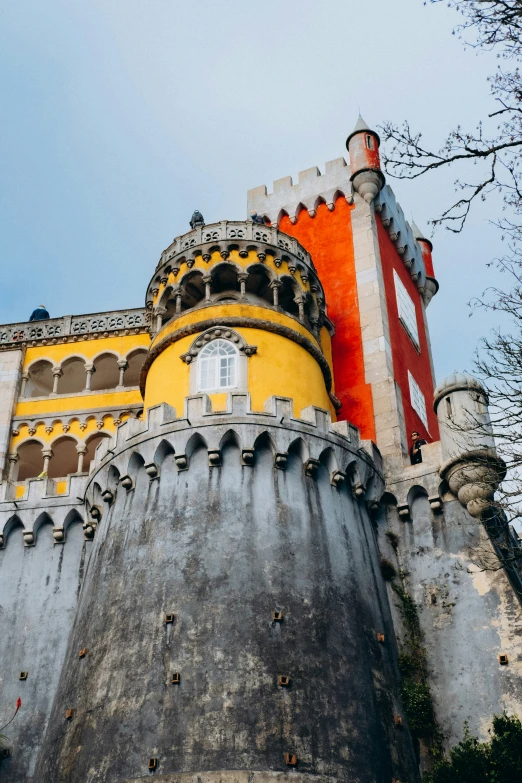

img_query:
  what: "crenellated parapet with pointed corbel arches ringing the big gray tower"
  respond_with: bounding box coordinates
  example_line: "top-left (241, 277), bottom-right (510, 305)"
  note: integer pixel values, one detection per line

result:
top-left (82, 393), bottom-right (383, 528)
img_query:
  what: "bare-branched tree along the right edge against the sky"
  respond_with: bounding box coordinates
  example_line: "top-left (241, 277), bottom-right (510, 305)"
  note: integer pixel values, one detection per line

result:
top-left (381, 0), bottom-right (522, 585)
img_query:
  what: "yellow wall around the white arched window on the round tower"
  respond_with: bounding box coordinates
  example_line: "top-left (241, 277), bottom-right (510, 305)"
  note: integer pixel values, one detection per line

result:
top-left (145, 304), bottom-right (335, 419)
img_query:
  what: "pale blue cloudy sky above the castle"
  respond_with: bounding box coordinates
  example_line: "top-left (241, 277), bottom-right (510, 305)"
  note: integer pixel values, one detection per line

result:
top-left (0, 0), bottom-right (502, 380)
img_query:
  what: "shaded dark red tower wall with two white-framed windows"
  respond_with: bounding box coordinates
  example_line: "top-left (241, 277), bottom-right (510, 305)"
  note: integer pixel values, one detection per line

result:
top-left (376, 215), bottom-right (439, 442)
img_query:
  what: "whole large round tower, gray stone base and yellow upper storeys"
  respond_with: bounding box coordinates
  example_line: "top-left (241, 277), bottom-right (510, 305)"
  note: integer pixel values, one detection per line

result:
top-left (35, 222), bottom-right (418, 783)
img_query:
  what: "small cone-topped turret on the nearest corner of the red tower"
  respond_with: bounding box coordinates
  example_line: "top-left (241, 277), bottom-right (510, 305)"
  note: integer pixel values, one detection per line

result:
top-left (346, 115), bottom-right (386, 204)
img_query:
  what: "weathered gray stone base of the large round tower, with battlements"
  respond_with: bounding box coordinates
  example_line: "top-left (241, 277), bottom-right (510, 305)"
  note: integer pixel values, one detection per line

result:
top-left (37, 401), bottom-right (418, 783)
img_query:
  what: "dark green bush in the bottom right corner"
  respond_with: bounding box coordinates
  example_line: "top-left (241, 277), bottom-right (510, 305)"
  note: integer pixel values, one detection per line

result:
top-left (424, 713), bottom-right (522, 783)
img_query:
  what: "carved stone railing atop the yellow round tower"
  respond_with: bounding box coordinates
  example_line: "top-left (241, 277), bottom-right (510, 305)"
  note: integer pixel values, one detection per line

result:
top-left (157, 220), bottom-right (313, 269)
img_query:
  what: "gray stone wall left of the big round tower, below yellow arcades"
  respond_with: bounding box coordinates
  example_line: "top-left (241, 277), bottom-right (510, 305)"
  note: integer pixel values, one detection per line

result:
top-left (0, 516), bottom-right (91, 783)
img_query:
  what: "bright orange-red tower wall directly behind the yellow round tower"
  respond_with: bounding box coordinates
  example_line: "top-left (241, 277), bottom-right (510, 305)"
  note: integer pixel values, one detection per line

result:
top-left (279, 197), bottom-right (375, 441)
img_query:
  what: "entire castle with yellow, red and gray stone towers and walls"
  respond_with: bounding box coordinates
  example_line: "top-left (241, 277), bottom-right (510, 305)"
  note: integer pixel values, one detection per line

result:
top-left (0, 118), bottom-right (522, 783)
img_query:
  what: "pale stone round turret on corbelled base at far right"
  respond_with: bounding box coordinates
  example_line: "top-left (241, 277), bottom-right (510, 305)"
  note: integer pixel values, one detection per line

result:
top-left (434, 372), bottom-right (506, 517)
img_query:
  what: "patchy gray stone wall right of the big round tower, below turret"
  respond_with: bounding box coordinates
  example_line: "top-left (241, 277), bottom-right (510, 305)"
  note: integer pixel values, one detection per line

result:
top-left (379, 474), bottom-right (522, 748)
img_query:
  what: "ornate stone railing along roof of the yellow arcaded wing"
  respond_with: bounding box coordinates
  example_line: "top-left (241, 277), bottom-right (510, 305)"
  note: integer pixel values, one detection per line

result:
top-left (0, 307), bottom-right (148, 350)
